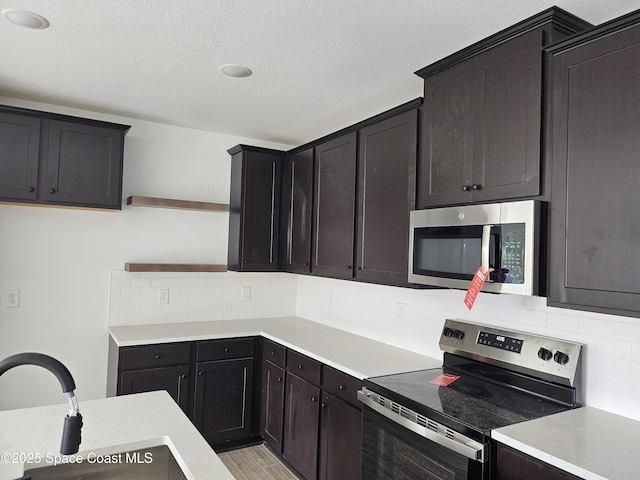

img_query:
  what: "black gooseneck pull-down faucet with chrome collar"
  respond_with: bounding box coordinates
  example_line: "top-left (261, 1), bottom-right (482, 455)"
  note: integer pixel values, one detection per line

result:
top-left (0, 353), bottom-right (82, 455)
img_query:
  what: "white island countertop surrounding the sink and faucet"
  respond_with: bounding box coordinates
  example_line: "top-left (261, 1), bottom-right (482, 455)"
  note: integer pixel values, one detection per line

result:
top-left (0, 391), bottom-right (234, 480)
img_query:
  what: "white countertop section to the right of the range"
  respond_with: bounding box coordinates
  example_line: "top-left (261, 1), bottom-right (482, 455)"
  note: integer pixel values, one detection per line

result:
top-left (491, 407), bottom-right (640, 480)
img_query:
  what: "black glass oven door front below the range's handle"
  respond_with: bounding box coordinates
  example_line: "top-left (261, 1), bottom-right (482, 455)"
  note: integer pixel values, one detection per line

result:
top-left (362, 406), bottom-right (483, 480)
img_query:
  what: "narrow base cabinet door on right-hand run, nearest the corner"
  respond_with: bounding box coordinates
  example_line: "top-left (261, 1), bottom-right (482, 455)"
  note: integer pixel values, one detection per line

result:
top-left (260, 362), bottom-right (285, 453)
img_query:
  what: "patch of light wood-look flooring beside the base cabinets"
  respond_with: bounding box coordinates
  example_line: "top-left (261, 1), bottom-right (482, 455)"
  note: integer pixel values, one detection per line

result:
top-left (218, 444), bottom-right (298, 480)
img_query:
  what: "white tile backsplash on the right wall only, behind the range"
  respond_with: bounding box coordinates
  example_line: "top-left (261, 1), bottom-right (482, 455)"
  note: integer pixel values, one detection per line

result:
top-left (296, 275), bottom-right (640, 420)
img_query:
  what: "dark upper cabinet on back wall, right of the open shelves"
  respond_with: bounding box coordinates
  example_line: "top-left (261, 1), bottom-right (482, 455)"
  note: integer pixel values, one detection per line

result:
top-left (228, 145), bottom-right (284, 272)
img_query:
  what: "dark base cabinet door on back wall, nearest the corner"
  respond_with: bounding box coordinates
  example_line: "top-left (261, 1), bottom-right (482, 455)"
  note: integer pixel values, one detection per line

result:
top-left (193, 358), bottom-right (253, 445)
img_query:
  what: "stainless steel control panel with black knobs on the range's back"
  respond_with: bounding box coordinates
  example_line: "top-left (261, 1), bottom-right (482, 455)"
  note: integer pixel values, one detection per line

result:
top-left (440, 319), bottom-right (582, 386)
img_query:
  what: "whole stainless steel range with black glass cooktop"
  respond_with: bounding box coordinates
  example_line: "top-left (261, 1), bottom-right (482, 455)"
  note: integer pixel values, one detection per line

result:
top-left (358, 320), bottom-right (582, 480)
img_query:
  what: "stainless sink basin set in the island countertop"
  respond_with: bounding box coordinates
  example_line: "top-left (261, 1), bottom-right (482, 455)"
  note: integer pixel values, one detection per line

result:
top-left (21, 444), bottom-right (187, 480)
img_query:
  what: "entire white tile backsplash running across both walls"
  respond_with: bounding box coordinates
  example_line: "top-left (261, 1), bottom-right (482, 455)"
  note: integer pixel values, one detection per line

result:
top-left (109, 271), bottom-right (640, 420)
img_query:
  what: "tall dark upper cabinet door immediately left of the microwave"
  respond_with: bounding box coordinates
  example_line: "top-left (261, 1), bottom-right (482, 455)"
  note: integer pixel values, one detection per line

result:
top-left (355, 110), bottom-right (418, 285)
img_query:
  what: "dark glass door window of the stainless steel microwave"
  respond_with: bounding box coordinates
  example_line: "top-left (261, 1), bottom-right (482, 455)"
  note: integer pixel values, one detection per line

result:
top-left (413, 225), bottom-right (495, 281)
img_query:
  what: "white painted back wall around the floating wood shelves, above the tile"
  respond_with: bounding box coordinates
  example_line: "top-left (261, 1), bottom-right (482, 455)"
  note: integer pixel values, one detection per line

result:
top-left (0, 98), bottom-right (290, 409)
